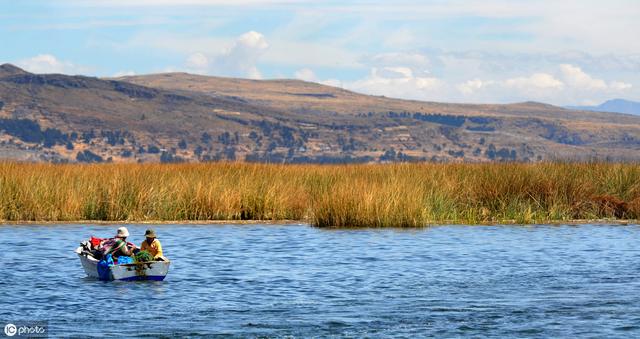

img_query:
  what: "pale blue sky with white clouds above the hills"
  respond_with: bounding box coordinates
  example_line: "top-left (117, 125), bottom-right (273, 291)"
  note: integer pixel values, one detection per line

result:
top-left (0, 0), bottom-right (640, 105)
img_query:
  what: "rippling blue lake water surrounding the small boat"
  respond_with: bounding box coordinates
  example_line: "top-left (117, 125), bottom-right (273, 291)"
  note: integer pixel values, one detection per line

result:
top-left (0, 225), bottom-right (640, 338)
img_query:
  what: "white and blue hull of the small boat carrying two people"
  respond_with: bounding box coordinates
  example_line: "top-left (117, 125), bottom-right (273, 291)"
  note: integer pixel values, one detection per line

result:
top-left (75, 246), bottom-right (171, 281)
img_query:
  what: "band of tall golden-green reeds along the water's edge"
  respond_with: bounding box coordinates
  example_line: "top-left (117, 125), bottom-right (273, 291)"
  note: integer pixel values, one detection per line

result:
top-left (0, 162), bottom-right (640, 227)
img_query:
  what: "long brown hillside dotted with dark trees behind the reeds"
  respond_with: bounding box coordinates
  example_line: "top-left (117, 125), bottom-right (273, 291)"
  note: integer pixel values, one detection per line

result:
top-left (0, 64), bottom-right (640, 163)
